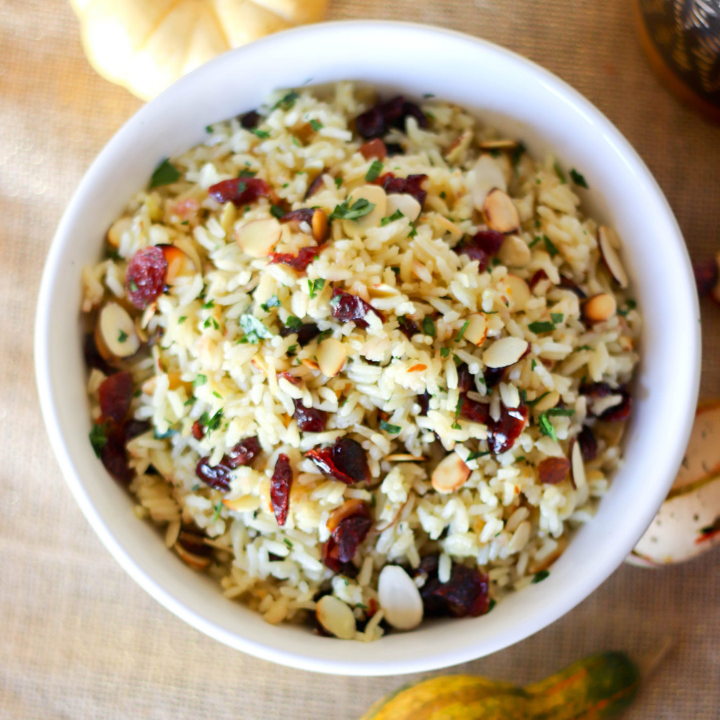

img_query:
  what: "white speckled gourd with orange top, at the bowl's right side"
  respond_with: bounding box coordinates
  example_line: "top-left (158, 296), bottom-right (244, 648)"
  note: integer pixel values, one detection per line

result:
top-left (627, 401), bottom-right (720, 567)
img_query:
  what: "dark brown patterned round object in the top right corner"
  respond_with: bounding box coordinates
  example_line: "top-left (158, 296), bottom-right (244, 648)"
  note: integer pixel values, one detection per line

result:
top-left (637, 0), bottom-right (720, 122)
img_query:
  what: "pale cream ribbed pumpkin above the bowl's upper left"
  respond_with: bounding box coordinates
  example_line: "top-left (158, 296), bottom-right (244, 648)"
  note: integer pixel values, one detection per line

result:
top-left (70, 0), bottom-right (328, 100)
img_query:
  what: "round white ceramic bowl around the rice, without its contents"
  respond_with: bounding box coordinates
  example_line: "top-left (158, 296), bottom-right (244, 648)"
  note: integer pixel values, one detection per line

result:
top-left (36, 22), bottom-right (700, 675)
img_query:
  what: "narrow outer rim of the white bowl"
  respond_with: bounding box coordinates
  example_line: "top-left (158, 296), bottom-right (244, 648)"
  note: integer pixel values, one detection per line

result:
top-left (34, 20), bottom-right (701, 676)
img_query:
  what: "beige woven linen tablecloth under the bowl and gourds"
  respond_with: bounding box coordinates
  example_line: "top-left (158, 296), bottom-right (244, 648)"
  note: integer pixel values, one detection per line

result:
top-left (0, 0), bottom-right (720, 720)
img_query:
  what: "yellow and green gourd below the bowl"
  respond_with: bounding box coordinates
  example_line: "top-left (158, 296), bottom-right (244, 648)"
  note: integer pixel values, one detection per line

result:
top-left (362, 652), bottom-right (640, 720)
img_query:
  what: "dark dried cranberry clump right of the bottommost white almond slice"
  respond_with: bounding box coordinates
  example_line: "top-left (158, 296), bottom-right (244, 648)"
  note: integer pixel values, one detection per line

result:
top-left (420, 564), bottom-right (490, 617)
